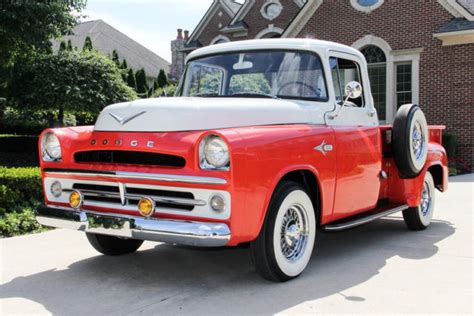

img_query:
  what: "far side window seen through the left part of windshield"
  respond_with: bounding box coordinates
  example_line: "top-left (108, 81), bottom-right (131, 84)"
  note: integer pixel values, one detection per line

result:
top-left (189, 64), bottom-right (224, 96)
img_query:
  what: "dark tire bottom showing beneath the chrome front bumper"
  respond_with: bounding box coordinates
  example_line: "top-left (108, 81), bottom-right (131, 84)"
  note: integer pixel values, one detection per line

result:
top-left (86, 233), bottom-right (143, 256)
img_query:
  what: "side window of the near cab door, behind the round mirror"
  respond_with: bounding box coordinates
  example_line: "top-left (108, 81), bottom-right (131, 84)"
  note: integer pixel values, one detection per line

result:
top-left (329, 57), bottom-right (364, 107)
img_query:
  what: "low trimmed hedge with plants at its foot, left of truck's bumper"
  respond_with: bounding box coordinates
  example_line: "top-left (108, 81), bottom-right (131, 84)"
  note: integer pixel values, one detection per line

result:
top-left (0, 167), bottom-right (44, 237)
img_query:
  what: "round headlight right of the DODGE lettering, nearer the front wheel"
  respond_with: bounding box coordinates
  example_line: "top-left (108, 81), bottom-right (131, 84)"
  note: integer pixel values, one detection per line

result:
top-left (199, 135), bottom-right (230, 169)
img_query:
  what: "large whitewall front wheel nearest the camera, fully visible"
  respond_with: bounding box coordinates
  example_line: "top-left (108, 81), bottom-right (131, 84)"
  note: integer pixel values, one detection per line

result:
top-left (250, 182), bottom-right (316, 282)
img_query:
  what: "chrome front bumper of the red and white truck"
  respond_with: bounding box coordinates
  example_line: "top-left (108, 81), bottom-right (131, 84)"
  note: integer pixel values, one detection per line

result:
top-left (36, 207), bottom-right (230, 247)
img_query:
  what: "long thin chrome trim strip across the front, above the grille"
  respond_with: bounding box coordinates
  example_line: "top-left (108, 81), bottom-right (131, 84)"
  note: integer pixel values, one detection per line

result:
top-left (45, 171), bottom-right (227, 184)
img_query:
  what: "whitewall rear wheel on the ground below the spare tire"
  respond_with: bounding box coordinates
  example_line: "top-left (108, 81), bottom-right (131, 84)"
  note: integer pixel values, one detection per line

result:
top-left (403, 172), bottom-right (435, 230)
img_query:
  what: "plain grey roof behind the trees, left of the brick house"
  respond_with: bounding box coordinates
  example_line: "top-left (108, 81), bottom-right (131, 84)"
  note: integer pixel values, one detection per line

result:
top-left (53, 20), bottom-right (170, 77)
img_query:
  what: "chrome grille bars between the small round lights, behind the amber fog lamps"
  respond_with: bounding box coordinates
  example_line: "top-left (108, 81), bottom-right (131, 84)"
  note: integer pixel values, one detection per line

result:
top-left (72, 183), bottom-right (206, 211)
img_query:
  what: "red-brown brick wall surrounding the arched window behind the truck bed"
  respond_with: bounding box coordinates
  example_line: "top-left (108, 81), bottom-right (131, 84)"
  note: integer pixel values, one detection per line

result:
top-left (298, 0), bottom-right (474, 170)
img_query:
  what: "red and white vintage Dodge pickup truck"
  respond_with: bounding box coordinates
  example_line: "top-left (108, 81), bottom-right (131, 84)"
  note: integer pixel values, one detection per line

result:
top-left (37, 39), bottom-right (448, 281)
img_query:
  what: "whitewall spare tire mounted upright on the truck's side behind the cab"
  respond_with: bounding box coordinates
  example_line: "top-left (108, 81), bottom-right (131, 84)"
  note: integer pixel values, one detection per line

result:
top-left (392, 104), bottom-right (429, 178)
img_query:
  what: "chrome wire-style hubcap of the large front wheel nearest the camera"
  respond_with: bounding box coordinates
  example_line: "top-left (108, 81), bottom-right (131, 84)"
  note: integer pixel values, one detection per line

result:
top-left (280, 205), bottom-right (308, 261)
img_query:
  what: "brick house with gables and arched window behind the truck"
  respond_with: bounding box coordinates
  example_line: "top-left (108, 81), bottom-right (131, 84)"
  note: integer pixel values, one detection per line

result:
top-left (172, 0), bottom-right (474, 170)
